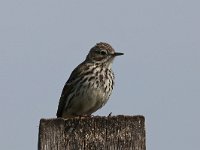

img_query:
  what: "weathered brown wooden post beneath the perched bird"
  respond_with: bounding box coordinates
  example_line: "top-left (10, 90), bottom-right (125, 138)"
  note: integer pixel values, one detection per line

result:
top-left (38, 116), bottom-right (146, 150)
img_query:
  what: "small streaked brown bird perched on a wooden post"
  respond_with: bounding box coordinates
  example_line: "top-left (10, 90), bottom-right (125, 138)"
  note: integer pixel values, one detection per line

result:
top-left (56, 42), bottom-right (123, 118)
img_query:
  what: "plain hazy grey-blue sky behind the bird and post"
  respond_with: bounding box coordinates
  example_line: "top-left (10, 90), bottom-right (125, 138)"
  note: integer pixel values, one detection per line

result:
top-left (0, 0), bottom-right (200, 150)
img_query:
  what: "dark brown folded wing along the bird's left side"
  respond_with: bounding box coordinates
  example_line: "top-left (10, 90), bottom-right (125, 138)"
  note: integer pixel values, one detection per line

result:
top-left (56, 63), bottom-right (89, 118)
